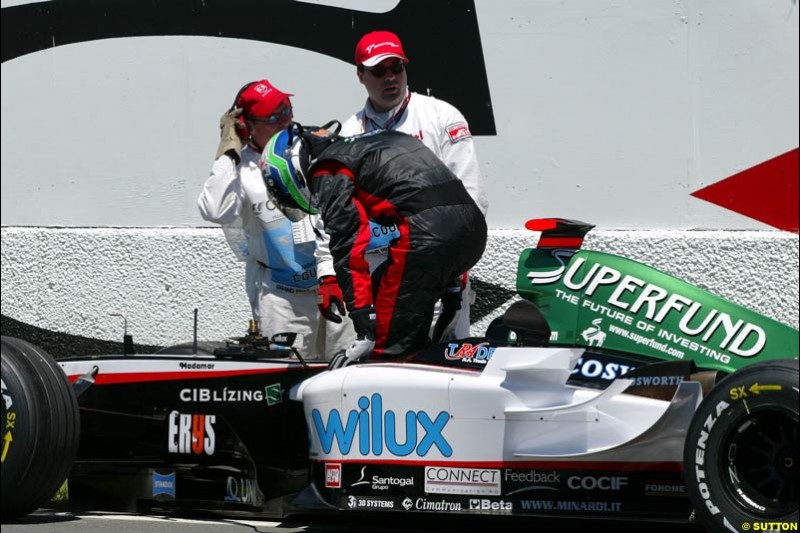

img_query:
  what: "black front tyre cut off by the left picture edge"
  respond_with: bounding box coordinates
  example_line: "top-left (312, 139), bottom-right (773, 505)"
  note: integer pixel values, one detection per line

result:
top-left (1, 337), bottom-right (80, 522)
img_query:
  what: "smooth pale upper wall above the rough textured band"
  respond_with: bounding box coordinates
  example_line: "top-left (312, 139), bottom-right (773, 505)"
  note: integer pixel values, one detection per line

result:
top-left (1, 0), bottom-right (800, 229)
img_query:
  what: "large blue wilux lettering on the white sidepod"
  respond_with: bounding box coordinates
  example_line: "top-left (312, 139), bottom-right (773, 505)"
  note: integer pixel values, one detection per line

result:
top-left (311, 393), bottom-right (453, 457)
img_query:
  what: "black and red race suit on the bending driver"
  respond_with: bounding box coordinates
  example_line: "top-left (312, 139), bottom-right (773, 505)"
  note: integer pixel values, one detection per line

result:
top-left (309, 131), bottom-right (486, 359)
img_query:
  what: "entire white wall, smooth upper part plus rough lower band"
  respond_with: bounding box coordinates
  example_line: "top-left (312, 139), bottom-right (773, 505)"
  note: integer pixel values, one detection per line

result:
top-left (0, 0), bottom-right (800, 344)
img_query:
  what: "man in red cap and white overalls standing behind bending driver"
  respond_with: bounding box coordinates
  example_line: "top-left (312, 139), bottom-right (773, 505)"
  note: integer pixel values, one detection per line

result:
top-left (318, 31), bottom-right (488, 342)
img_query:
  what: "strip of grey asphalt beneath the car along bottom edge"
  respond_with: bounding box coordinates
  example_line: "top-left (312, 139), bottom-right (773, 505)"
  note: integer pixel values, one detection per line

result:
top-left (3, 510), bottom-right (705, 533)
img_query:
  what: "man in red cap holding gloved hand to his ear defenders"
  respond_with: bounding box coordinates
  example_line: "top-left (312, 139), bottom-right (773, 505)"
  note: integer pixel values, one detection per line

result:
top-left (197, 80), bottom-right (355, 359)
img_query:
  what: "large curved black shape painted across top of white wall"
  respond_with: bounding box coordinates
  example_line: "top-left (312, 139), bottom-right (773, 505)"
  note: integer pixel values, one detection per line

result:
top-left (2, 0), bottom-right (497, 135)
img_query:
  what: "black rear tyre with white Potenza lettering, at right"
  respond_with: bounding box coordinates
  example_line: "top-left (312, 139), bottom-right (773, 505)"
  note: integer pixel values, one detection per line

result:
top-left (684, 359), bottom-right (800, 532)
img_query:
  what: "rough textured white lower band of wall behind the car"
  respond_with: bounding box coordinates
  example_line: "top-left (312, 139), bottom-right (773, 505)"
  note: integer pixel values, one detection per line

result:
top-left (2, 228), bottom-right (798, 346)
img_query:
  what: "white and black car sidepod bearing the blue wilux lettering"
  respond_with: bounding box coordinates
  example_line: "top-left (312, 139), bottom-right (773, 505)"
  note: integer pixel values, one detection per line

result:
top-left (296, 348), bottom-right (702, 519)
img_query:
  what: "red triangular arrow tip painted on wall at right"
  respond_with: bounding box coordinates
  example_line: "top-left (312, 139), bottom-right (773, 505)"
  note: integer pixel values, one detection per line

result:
top-left (692, 148), bottom-right (800, 233)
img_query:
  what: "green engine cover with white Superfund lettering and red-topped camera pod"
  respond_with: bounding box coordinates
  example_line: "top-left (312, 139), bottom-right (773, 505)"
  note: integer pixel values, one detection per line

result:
top-left (517, 219), bottom-right (798, 372)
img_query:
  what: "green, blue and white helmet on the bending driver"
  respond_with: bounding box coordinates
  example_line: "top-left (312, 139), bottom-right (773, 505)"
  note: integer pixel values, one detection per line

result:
top-left (261, 125), bottom-right (319, 222)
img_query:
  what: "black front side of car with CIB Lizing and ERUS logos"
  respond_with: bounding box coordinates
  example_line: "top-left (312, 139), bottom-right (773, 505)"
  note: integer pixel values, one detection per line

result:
top-left (61, 355), bottom-right (326, 515)
